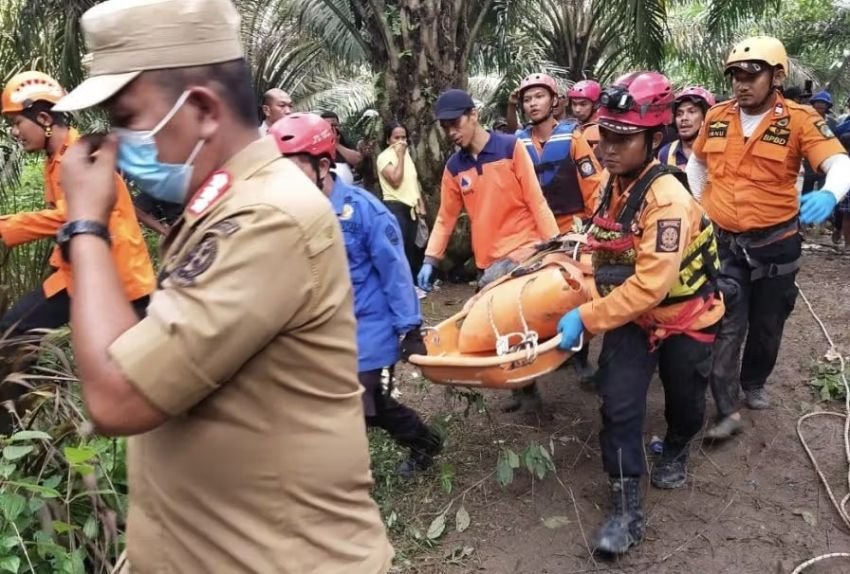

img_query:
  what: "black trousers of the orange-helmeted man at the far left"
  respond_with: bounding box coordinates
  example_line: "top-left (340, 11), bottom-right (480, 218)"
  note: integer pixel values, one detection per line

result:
top-left (0, 287), bottom-right (150, 336)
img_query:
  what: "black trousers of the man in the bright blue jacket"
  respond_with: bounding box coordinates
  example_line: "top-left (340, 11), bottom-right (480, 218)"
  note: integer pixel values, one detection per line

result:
top-left (357, 367), bottom-right (439, 454)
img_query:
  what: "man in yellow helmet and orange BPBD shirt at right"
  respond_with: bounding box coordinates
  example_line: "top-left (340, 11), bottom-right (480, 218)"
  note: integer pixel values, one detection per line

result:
top-left (687, 36), bottom-right (850, 440)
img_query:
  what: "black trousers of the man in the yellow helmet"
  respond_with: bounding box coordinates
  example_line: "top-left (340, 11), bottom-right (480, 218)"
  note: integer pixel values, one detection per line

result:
top-left (711, 234), bottom-right (802, 417)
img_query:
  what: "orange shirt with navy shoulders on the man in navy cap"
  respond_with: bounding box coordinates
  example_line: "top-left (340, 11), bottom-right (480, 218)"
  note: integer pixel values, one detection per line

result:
top-left (425, 133), bottom-right (558, 269)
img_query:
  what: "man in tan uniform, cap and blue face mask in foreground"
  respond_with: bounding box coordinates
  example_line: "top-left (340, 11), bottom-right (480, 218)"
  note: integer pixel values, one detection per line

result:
top-left (58, 0), bottom-right (392, 574)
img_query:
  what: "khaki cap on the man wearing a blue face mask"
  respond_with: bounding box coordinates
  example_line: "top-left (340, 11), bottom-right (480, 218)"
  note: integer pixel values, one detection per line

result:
top-left (53, 0), bottom-right (244, 112)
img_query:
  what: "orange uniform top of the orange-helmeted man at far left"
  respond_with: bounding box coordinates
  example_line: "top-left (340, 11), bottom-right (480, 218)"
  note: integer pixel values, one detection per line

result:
top-left (0, 129), bottom-right (156, 301)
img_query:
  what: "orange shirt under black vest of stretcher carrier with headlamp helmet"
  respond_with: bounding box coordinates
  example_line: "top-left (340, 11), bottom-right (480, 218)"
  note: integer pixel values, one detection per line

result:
top-left (579, 161), bottom-right (724, 334)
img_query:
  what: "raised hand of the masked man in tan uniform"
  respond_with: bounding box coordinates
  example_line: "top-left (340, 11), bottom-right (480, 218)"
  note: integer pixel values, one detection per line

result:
top-left (60, 134), bottom-right (118, 225)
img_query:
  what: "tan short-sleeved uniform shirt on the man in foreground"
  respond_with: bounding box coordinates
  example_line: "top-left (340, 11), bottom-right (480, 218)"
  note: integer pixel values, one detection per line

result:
top-left (109, 138), bottom-right (393, 574)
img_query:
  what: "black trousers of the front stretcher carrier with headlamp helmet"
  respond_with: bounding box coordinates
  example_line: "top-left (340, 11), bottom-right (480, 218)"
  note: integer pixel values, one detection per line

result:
top-left (596, 323), bottom-right (715, 477)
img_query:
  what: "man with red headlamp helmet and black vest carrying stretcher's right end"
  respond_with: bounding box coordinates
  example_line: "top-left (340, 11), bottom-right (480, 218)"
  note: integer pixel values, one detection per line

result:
top-left (558, 72), bottom-right (723, 554)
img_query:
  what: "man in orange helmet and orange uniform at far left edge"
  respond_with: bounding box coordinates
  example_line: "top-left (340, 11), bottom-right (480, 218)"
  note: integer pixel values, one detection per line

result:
top-left (0, 71), bottom-right (156, 333)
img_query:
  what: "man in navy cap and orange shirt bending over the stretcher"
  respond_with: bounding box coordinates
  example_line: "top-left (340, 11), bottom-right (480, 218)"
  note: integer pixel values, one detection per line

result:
top-left (417, 89), bottom-right (558, 412)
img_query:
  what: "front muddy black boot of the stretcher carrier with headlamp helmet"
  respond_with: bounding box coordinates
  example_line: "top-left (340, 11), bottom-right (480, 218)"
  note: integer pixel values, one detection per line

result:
top-left (593, 477), bottom-right (644, 555)
